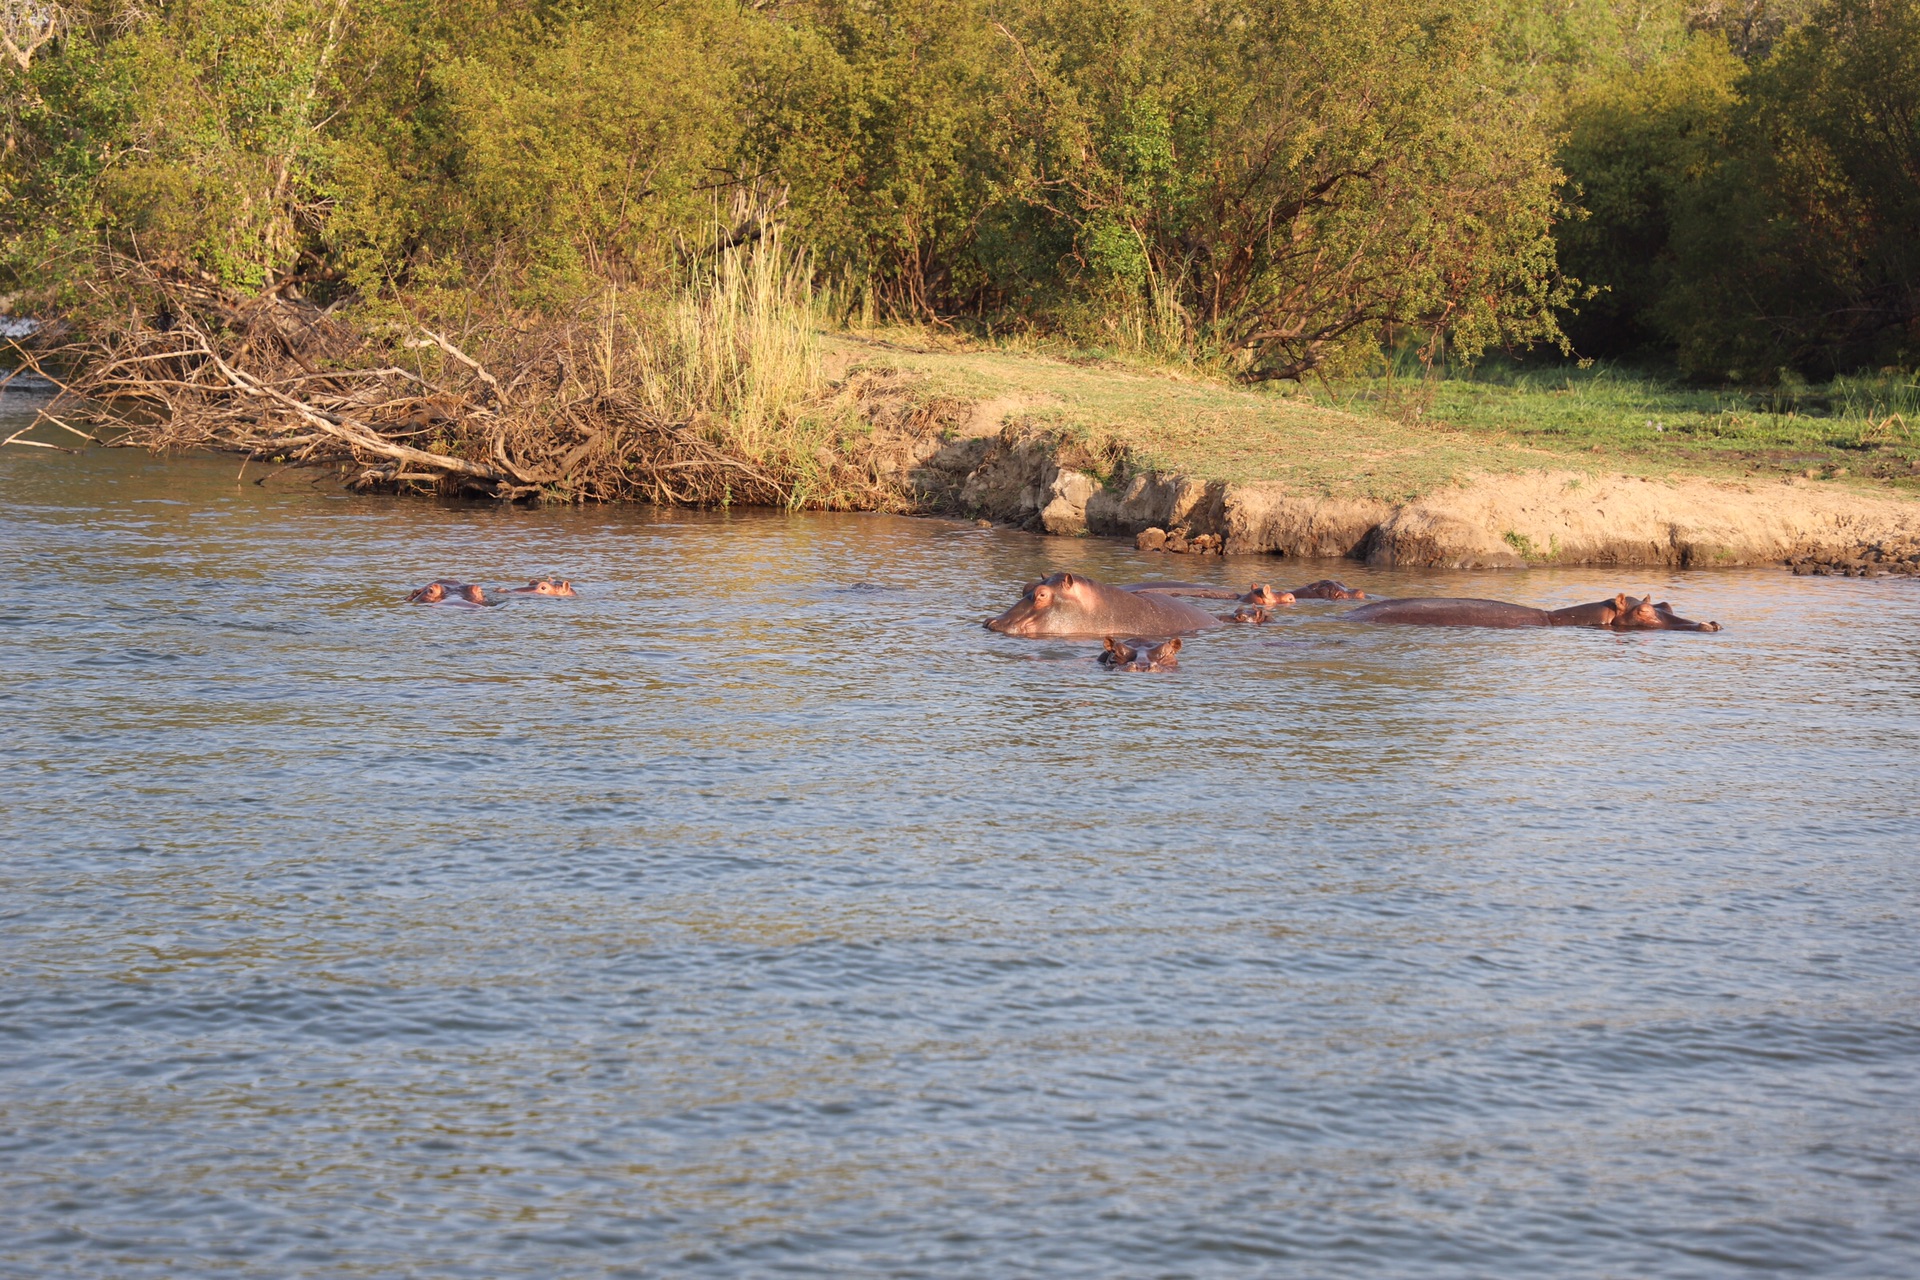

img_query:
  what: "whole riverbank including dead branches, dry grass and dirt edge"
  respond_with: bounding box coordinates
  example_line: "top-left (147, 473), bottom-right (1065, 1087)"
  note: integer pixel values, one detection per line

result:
top-left (21, 303), bottom-right (1920, 574)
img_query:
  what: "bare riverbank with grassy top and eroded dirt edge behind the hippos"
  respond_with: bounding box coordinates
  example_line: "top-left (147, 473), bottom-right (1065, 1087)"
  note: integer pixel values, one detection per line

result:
top-left (826, 336), bottom-right (1920, 574)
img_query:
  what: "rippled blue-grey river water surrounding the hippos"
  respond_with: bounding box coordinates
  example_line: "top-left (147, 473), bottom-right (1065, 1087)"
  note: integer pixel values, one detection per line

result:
top-left (0, 416), bottom-right (1920, 1278)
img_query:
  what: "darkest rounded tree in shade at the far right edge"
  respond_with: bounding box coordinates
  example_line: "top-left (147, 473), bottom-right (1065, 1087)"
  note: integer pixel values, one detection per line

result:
top-left (1659, 0), bottom-right (1920, 378)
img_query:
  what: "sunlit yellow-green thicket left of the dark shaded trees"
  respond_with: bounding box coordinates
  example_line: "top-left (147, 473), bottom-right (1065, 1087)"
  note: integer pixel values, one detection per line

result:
top-left (0, 0), bottom-right (1565, 378)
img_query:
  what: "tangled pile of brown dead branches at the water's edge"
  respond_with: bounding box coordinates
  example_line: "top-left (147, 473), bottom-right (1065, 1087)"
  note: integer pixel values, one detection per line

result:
top-left (15, 263), bottom-right (845, 507)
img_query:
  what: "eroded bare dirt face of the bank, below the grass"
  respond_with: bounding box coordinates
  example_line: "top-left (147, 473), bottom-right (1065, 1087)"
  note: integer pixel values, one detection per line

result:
top-left (899, 415), bottom-right (1920, 572)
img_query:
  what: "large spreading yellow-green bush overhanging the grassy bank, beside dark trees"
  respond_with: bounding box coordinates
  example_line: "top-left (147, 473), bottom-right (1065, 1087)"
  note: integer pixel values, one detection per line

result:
top-left (1010, 0), bottom-right (1565, 380)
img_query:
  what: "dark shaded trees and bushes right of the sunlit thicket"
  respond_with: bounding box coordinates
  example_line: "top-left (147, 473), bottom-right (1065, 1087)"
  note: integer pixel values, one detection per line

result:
top-left (1559, 0), bottom-right (1920, 382)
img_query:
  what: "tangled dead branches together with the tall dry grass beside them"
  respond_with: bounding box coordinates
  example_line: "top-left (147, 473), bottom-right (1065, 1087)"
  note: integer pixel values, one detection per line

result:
top-left (21, 230), bottom-right (893, 507)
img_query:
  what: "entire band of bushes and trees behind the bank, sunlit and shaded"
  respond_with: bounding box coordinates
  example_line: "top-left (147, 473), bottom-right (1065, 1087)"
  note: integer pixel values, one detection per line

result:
top-left (0, 0), bottom-right (1920, 378)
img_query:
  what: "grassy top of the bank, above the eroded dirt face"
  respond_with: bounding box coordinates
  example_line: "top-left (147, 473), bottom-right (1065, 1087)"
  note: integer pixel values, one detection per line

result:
top-left (828, 334), bottom-right (1920, 501)
